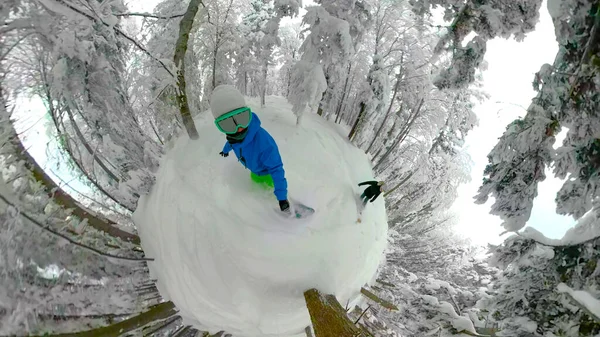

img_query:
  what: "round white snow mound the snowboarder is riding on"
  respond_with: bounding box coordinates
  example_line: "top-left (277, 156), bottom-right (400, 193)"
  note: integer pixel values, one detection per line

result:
top-left (134, 97), bottom-right (387, 337)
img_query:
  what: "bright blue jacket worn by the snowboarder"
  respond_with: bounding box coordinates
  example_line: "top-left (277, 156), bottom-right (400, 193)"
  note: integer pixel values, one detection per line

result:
top-left (223, 112), bottom-right (287, 200)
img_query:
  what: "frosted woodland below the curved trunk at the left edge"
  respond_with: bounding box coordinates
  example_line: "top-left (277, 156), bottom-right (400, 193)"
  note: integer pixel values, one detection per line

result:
top-left (0, 86), bottom-right (147, 335)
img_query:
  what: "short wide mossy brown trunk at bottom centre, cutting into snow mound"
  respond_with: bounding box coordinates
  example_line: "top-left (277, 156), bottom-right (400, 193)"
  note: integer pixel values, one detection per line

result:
top-left (304, 289), bottom-right (367, 337)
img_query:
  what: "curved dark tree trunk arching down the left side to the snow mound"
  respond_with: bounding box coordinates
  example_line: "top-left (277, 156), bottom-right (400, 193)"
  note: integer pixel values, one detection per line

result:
top-left (8, 125), bottom-right (140, 244)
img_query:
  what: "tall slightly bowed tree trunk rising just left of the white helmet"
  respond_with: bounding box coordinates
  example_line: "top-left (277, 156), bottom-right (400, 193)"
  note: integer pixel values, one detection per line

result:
top-left (173, 0), bottom-right (202, 139)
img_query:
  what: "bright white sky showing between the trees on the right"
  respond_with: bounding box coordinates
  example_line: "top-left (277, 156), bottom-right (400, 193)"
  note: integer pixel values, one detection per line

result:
top-left (453, 1), bottom-right (575, 244)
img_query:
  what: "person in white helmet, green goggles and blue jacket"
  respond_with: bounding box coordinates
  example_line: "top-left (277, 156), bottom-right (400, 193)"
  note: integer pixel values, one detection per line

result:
top-left (210, 85), bottom-right (291, 214)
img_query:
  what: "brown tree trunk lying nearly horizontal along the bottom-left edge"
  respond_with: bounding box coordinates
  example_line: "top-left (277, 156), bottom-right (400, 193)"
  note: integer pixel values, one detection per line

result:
top-left (35, 302), bottom-right (177, 337)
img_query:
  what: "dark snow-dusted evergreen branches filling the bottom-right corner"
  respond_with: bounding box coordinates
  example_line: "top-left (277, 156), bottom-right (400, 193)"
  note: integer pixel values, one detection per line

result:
top-left (481, 214), bottom-right (600, 336)
